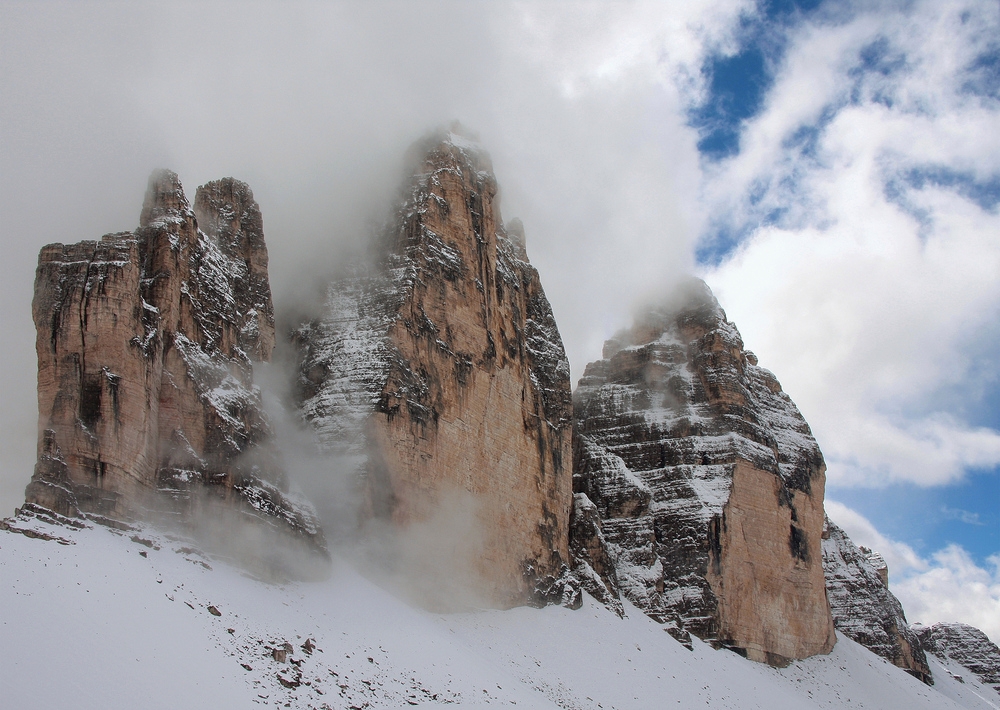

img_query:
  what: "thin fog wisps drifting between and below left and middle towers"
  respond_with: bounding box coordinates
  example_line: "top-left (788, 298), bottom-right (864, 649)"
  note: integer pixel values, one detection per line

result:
top-left (254, 354), bottom-right (495, 611)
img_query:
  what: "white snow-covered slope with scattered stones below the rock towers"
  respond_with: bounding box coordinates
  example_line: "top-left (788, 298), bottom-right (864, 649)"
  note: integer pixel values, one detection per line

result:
top-left (0, 520), bottom-right (1000, 710)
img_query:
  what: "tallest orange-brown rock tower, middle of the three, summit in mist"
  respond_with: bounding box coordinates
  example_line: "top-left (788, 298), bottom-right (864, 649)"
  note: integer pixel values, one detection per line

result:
top-left (295, 134), bottom-right (572, 606)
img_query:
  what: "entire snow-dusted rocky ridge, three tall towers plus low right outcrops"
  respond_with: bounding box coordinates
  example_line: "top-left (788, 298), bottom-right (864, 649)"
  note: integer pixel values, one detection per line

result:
top-left (21, 133), bottom-right (1000, 689)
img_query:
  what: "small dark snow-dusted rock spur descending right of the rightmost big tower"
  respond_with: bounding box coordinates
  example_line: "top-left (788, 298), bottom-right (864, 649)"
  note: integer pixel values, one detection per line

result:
top-left (823, 518), bottom-right (934, 685)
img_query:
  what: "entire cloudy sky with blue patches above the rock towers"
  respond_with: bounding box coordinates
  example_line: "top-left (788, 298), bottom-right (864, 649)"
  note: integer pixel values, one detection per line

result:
top-left (0, 0), bottom-right (1000, 641)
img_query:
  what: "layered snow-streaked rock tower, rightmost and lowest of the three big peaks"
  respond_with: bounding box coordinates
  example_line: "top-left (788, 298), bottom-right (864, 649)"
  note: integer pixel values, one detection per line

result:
top-left (573, 279), bottom-right (835, 664)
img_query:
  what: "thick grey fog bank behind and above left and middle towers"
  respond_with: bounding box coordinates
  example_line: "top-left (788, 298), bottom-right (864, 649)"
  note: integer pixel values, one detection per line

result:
top-left (0, 2), bottom-right (720, 512)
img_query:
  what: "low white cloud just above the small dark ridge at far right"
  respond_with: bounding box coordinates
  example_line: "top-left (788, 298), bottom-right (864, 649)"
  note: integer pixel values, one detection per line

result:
top-left (826, 501), bottom-right (1000, 642)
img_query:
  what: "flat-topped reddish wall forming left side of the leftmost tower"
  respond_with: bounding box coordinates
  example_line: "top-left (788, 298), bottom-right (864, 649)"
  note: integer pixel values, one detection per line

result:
top-left (26, 239), bottom-right (154, 516)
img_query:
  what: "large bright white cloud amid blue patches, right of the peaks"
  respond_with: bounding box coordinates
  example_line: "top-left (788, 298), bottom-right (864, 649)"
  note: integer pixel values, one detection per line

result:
top-left (705, 2), bottom-right (1000, 485)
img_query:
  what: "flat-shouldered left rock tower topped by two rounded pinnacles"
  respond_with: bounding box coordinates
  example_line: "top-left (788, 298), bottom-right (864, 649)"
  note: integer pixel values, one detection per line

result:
top-left (26, 171), bottom-right (325, 580)
